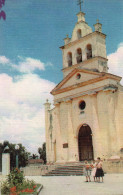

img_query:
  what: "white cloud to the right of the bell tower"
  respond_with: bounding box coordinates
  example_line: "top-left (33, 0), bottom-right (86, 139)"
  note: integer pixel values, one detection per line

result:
top-left (108, 43), bottom-right (123, 84)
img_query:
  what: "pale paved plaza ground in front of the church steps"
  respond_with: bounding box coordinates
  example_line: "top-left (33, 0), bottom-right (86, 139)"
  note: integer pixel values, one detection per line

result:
top-left (27, 174), bottom-right (123, 195)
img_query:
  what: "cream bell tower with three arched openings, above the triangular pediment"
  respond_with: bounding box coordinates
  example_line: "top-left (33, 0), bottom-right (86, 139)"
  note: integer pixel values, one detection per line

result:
top-left (60, 9), bottom-right (108, 77)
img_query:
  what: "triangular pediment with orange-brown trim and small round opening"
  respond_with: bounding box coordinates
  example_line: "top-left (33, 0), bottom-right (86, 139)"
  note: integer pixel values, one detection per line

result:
top-left (51, 69), bottom-right (102, 94)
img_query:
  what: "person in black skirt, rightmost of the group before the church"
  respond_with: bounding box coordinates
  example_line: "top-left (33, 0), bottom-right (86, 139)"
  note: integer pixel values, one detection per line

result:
top-left (95, 157), bottom-right (104, 182)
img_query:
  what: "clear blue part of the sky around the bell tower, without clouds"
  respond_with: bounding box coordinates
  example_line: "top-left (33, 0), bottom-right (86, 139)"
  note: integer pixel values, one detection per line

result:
top-left (0, 0), bottom-right (123, 83)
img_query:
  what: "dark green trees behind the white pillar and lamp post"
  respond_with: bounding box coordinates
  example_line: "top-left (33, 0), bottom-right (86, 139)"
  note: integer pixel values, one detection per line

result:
top-left (0, 141), bottom-right (30, 169)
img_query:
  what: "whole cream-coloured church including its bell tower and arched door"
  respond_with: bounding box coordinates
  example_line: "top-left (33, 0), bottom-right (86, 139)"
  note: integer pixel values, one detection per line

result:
top-left (45, 11), bottom-right (123, 163)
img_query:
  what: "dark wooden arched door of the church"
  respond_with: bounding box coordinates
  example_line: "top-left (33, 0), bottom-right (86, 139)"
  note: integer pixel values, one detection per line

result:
top-left (78, 124), bottom-right (93, 161)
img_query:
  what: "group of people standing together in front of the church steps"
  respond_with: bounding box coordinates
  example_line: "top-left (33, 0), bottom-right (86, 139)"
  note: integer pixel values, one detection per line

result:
top-left (84, 157), bottom-right (104, 182)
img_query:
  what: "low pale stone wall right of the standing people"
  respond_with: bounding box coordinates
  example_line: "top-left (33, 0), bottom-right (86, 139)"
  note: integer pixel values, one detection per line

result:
top-left (103, 160), bottom-right (123, 173)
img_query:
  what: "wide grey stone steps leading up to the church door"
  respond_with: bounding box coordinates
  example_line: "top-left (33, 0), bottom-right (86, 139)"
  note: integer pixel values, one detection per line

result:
top-left (42, 162), bottom-right (83, 176)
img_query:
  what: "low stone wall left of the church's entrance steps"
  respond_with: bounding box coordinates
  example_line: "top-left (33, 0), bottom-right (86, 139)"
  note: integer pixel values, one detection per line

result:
top-left (21, 165), bottom-right (56, 176)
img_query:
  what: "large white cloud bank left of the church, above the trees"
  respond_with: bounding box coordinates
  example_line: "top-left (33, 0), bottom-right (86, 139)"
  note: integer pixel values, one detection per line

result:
top-left (0, 74), bottom-right (55, 153)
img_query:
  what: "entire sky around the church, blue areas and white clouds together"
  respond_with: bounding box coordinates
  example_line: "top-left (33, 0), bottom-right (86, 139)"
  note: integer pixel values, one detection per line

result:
top-left (0, 0), bottom-right (123, 155)
